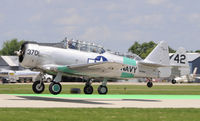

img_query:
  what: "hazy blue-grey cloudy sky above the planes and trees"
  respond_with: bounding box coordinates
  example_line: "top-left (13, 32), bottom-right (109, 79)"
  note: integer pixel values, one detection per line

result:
top-left (0, 0), bottom-right (200, 52)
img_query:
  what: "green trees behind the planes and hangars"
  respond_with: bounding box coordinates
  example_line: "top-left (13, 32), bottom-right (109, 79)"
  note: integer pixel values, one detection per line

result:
top-left (0, 39), bottom-right (200, 59)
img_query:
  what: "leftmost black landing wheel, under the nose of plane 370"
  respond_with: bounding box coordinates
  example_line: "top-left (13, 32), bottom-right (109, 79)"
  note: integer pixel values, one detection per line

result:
top-left (32, 81), bottom-right (45, 94)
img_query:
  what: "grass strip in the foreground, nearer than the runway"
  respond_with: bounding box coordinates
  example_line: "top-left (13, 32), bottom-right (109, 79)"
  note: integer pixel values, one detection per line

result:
top-left (0, 108), bottom-right (200, 121)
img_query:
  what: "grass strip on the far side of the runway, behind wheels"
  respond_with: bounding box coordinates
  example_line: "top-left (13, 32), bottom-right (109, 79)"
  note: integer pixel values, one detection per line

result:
top-left (0, 84), bottom-right (200, 95)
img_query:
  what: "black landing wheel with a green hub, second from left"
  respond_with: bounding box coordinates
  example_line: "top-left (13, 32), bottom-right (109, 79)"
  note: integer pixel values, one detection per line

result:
top-left (49, 82), bottom-right (62, 95)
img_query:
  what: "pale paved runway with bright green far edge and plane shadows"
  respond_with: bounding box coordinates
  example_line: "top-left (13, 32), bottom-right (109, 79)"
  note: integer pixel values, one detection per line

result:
top-left (0, 94), bottom-right (200, 108)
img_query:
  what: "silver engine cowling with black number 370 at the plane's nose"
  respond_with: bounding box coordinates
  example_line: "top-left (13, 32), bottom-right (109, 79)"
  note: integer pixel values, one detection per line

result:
top-left (19, 42), bottom-right (40, 68)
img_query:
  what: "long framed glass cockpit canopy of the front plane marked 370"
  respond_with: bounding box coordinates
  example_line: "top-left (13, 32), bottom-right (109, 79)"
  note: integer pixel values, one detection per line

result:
top-left (65, 40), bottom-right (105, 54)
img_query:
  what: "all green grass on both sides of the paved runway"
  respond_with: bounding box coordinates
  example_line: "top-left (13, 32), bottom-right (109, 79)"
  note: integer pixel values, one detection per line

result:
top-left (0, 84), bottom-right (200, 121)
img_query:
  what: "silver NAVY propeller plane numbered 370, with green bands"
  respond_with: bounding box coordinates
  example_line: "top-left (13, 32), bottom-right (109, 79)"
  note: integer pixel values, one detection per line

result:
top-left (18, 40), bottom-right (170, 94)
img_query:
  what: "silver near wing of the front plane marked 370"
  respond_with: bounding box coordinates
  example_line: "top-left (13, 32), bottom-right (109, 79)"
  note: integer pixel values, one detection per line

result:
top-left (43, 62), bottom-right (125, 78)
